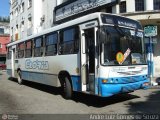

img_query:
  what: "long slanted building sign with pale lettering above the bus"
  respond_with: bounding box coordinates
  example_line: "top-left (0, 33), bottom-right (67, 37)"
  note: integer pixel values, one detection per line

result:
top-left (55, 0), bottom-right (117, 22)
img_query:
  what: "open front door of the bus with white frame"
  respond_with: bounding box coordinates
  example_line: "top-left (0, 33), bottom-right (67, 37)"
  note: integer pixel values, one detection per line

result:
top-left (80, 21), bottom-right (98, 93)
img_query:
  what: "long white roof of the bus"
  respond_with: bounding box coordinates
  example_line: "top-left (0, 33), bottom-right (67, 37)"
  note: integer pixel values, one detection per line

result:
top-left (7, 12), bottom-right (141, 47)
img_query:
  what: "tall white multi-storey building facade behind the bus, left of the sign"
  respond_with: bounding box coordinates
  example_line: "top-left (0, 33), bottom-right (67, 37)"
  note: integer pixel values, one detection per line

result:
top-left (10, 0), bottom-right (60, 41)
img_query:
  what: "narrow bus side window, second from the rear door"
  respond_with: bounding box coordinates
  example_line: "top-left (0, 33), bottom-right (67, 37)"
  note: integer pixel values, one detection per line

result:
top-left (25, 40), bottom-right (32, 58)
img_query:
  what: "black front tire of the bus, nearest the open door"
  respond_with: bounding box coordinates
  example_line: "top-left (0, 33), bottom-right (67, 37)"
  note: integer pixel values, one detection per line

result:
top-left (63, 77), bottom-right (73, 99)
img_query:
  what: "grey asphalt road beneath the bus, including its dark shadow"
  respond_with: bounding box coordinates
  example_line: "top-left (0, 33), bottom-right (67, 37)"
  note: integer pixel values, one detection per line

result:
top-left (0, 71), bottom-right (160, 119)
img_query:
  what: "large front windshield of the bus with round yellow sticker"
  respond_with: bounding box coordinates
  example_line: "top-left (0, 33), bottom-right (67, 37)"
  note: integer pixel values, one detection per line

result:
top-left (100, 25), bottom-right (146, 65)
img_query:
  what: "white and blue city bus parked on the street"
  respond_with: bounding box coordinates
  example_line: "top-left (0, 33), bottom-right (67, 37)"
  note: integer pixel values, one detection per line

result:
top-left (7, 12), bottom-right (149, 99)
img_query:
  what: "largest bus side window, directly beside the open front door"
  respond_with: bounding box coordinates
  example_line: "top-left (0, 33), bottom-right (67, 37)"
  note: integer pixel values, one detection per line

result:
top-left (59, 28), bottom-right (79, 55)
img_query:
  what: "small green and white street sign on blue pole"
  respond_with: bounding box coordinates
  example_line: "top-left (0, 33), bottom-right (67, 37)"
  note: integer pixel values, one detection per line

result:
top-left (144, 25), bottom-right (157, 37)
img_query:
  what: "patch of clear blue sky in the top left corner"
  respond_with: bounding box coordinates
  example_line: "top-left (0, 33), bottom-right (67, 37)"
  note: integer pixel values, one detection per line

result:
top-left (0, 0), bottom-right (10, 17)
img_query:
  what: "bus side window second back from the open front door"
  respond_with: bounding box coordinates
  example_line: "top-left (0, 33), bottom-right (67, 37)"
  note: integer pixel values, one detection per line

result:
top-left (45, 33), bottom-right (58, 56)
